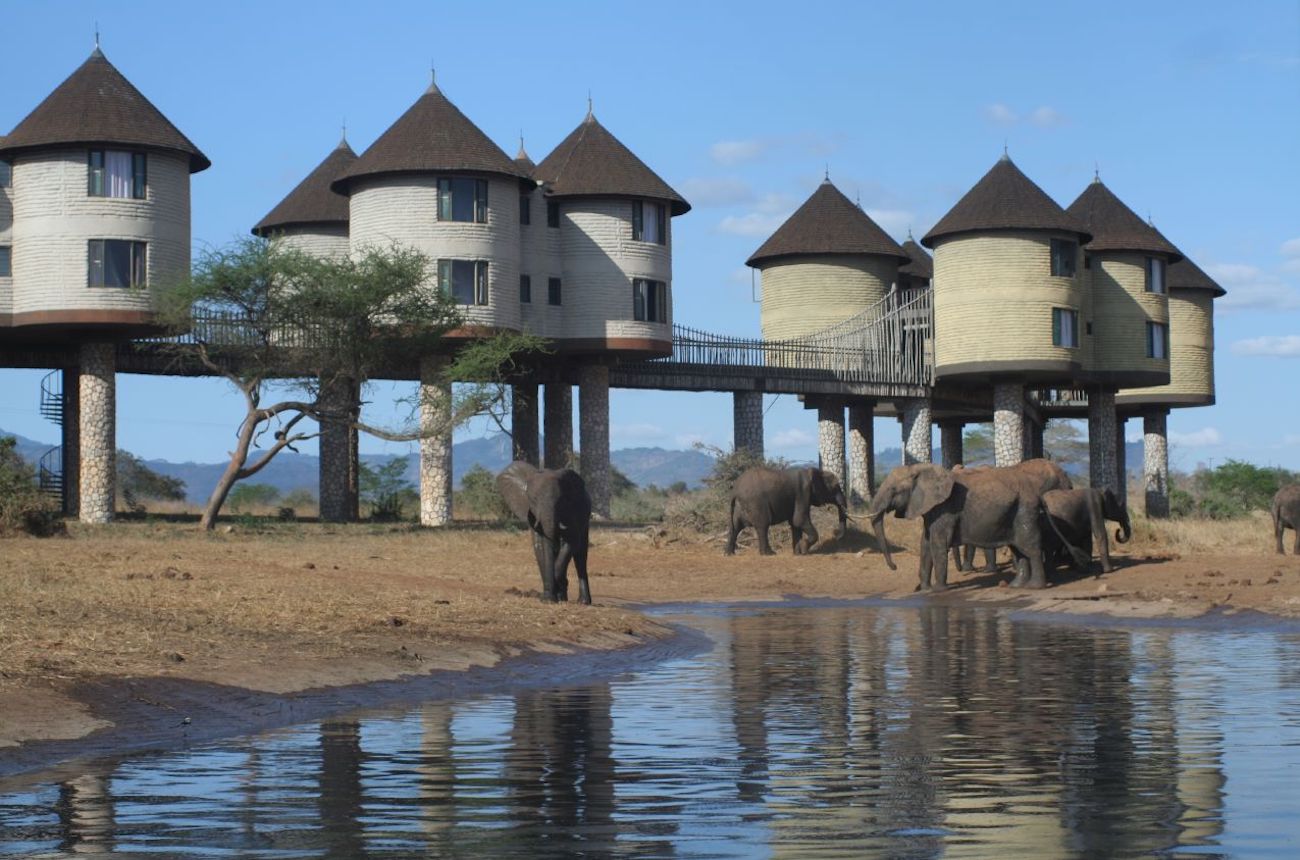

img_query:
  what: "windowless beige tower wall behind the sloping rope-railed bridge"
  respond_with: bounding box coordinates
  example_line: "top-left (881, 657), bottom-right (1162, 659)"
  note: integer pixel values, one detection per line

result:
top-left (759, 255), bottom-right (898, 340)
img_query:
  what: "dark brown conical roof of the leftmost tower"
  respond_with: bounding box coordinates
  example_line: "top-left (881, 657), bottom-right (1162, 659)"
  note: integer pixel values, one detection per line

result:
top-left (0, 48), bottom-right (212, 173)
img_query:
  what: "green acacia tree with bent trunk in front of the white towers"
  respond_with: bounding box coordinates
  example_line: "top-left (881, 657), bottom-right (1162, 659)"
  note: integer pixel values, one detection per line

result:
top-left (161, 239), bottom-right (543, 530)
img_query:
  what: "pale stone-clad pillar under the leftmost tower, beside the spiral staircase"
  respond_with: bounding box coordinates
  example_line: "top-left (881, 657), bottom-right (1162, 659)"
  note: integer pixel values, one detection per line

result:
top-left (78, 343), bottom-right (117, 524)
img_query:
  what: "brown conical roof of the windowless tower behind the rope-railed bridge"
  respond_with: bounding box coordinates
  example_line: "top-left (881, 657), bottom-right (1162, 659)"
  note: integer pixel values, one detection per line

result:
top-left (746, 179), bottom-right (911, 266)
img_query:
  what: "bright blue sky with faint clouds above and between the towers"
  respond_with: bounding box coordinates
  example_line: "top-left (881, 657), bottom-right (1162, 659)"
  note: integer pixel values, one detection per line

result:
top-left (0, 0), bottom-right (1300, 469)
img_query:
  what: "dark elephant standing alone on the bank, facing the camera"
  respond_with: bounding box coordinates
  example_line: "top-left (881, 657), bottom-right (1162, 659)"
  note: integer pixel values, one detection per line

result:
top-left (497, 460), bottom-right (592, 604)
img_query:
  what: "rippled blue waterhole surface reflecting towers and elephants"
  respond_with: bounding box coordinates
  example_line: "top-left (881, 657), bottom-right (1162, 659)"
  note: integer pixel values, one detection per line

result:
top-left (0, 607), bottom-right (1300, 857)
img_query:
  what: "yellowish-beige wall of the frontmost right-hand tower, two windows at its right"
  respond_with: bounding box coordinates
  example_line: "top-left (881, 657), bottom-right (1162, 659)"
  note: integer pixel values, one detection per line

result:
top-left (933, 231), bottom-right (1088, 377)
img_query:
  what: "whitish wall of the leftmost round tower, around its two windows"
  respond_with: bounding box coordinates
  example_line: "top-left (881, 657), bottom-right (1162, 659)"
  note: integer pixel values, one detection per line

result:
top-left (12, 147), bottom-right (190, 322)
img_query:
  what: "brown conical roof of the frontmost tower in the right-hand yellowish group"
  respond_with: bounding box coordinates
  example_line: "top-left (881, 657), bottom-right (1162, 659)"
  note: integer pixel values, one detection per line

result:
top-left (920, 156), bottom-right (1092, 248)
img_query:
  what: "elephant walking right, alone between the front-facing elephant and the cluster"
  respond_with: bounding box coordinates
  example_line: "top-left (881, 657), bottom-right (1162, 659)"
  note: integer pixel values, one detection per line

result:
top-left (725, 466), bottom-right (849, 556)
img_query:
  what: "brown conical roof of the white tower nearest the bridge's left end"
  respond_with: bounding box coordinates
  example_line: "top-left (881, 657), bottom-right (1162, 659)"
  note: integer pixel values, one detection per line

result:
top-left (533, 113), bottom-right (690, 216)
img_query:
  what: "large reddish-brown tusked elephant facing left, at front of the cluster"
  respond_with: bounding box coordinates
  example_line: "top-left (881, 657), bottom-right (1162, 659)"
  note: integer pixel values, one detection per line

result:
top-left (867, 462), bottom-right (1078, 591)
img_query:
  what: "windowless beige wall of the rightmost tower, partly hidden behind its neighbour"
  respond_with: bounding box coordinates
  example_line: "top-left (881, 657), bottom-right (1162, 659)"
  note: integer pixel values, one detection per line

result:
top-left (1115, 288), bottom-right (1214, 405)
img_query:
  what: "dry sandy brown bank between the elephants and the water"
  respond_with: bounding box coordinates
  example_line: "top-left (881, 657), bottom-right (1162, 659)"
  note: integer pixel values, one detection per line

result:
top-left (0, 522), bottom-right (1300, 769)
